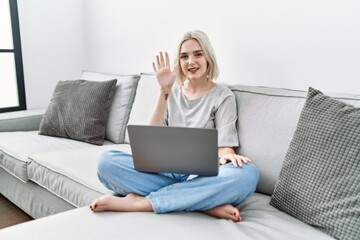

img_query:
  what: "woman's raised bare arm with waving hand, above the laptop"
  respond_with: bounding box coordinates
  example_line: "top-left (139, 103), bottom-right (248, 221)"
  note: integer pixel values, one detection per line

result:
top-left (149, 52), bottom-right (178, 125)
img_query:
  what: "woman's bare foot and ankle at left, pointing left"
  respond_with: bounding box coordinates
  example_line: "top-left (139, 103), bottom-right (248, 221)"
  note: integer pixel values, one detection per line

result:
top-left (90, 193), bottom-right (153, 212)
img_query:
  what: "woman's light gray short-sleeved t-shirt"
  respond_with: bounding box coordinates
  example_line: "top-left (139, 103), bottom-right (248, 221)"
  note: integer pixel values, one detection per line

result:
top-left (165, 84), bottom-right (239, 147)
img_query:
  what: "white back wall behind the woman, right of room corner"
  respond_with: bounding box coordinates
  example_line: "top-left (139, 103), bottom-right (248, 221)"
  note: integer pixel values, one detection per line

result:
top-left (84, 0), bottom-right (360, 93)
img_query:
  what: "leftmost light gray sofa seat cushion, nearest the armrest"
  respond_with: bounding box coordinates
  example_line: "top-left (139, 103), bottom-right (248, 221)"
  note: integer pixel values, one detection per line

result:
top-left (0, 131), bottom-right (112, 182)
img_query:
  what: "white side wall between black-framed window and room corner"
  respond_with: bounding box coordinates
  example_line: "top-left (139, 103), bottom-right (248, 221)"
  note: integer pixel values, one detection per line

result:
top-left (17, 0), bottom-right (85, 109)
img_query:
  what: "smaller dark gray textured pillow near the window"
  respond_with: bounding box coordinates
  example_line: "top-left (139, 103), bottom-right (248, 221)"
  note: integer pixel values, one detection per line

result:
top-left (39, 79), bottom-right (117, 145)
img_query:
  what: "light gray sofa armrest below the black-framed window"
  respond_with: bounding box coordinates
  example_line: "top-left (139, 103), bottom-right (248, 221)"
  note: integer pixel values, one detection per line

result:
top-left (0, 109), bottom-right (45, 132)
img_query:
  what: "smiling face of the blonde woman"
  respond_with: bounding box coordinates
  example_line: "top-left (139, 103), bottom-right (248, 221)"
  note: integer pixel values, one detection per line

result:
top-left (179, 39), bottom-right (207, 80)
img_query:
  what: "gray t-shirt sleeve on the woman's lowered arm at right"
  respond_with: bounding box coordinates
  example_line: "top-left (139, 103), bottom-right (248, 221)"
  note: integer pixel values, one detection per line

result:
top-left (215, 93), bottom-right (239, 147)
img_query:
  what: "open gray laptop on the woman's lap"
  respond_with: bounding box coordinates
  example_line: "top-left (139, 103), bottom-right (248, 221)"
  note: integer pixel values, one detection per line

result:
top-left (128, 125), bottom-right (219, 176)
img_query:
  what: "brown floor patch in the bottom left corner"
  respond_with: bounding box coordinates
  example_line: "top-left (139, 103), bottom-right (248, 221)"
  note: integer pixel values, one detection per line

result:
top-left (0, 194), bottom-right (33, 229)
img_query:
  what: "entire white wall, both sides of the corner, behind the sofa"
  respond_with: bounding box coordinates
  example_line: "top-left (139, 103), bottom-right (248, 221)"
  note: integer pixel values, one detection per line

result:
top-left (18, 0), bottom-right (360, 109)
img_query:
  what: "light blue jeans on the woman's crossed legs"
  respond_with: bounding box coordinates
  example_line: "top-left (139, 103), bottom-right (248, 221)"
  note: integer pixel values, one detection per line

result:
top-left (98, 150), bottom-right (259, 213)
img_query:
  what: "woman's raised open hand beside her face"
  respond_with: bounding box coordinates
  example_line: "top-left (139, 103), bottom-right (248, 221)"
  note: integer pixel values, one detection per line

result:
top-left (153, 52), bottom-right (178, 94)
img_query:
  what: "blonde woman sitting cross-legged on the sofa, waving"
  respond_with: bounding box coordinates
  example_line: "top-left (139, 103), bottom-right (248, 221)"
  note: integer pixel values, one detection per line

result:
top-left (90, 31), bottom-right (259, 222)
